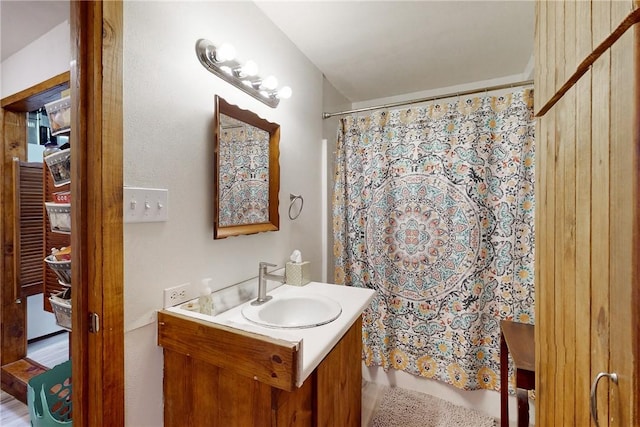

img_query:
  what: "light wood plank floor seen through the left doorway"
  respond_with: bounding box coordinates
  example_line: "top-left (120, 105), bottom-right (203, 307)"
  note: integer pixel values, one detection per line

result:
top-left (0, 332), bottom-right (69, 427)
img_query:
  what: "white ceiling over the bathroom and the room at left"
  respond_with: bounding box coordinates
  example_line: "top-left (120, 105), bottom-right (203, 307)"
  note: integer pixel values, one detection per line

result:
top-left (0, 0), bottom-right (534, 102)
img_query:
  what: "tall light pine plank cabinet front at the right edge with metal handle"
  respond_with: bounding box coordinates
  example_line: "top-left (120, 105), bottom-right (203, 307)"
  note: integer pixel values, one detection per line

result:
top-left (535, 1), bottom-right (640, 426)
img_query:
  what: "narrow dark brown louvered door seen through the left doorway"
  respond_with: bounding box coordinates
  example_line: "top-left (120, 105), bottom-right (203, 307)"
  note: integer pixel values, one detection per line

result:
top-left (13, 159), bottom-right (44, 299)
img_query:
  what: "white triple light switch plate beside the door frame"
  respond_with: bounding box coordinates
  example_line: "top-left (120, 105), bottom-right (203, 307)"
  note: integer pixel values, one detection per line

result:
top-left (123, 187), bottom-right (169, 222)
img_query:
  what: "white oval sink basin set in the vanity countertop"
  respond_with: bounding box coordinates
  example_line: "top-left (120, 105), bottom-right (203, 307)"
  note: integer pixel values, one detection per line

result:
top-left (242, 294), bottom-right (342, 328)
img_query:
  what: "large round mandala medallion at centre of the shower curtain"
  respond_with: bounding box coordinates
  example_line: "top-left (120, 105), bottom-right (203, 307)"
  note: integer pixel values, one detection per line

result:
top-left (362, 174), bottom-right (480, 301)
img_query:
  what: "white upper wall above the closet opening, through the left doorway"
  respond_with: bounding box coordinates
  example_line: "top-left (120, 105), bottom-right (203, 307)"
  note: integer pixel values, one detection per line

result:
top-left (0, 21), bottom-right (71, 98)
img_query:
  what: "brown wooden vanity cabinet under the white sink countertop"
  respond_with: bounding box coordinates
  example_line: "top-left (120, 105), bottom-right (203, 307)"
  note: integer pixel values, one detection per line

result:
top-left (158, 311), bottom-right (362, 427)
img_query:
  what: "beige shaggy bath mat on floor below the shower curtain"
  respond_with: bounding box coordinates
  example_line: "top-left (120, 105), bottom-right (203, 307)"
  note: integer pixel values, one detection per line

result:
top-left (369, 387), bottom-right (495, 427)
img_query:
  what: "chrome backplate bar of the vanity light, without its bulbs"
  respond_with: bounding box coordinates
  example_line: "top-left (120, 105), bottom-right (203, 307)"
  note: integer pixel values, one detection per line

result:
top-left (196, 39), bottom-right (280, 108)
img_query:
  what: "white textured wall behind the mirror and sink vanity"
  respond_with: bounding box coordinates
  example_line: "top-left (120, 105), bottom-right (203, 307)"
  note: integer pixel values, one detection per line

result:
top-left (124, 2), bottom-right (323, 426)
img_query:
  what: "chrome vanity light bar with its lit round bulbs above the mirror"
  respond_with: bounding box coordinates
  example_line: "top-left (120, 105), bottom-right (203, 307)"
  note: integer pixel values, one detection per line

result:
top-left (196, 39), bottom-right (292, 108)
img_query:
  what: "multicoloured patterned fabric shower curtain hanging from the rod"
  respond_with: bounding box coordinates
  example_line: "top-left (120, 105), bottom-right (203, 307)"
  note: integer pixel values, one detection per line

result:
top-left (333, 89), bottom-right (534, 390)
